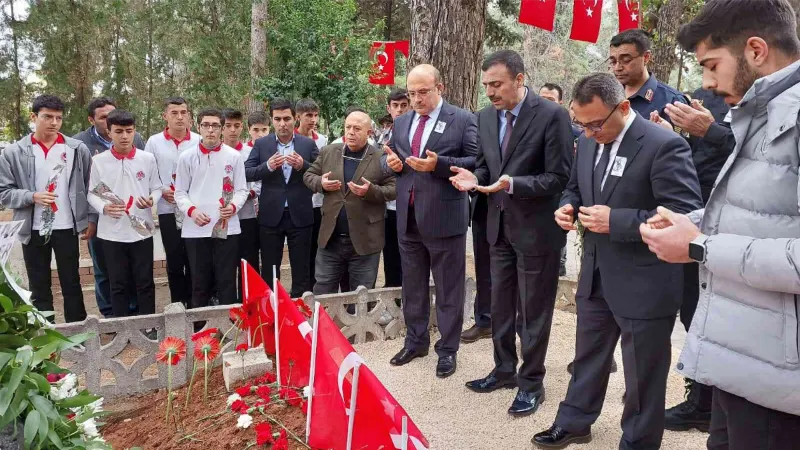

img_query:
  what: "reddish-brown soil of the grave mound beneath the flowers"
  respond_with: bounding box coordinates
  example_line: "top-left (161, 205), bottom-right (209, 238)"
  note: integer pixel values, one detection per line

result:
top-left (102, 367), bottom-right (308, 450)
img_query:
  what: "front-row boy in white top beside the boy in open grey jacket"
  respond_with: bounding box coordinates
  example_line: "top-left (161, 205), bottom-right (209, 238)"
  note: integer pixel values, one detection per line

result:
top-left (89, 109), bottom-right (161, 317)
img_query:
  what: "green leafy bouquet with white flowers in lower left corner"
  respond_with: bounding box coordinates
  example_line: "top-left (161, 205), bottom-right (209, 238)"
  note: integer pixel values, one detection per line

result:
top-left (0, 266), bottom-right (110, 449)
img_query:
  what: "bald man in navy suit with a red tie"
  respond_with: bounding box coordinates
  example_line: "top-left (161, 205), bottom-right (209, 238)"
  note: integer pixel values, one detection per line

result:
top-left (385, 64), bottom-right (478, 378)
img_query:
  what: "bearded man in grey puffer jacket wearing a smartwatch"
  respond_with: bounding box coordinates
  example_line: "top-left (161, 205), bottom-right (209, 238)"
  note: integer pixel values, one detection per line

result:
top-left (641, 0), bottom-right (800, 450)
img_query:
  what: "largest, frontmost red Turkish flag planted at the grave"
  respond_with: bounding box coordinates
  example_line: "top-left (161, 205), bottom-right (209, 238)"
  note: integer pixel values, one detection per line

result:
top-left (308, 308), bottom-right (428, 450)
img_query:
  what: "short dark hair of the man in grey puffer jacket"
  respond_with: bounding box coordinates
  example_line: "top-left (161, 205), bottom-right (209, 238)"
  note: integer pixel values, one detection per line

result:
top-left (678, 0), bottom-right (800, 56)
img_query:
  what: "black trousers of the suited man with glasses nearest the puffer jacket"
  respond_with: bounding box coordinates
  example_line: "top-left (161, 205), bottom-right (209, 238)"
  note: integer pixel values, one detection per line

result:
top-left (555, 271), bottom-right (675, 450)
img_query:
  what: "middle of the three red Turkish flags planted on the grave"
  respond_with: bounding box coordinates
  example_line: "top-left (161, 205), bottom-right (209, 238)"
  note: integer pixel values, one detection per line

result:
top-left (269, 281), bottom-right (311, 388)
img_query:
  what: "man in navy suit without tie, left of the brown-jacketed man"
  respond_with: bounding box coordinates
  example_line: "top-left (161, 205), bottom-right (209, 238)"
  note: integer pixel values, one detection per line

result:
top-left (244, 99), bottom-right (319, 297)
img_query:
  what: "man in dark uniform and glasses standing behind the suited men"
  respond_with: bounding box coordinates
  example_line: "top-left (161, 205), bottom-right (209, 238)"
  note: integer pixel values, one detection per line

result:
top-left (606, 29), bottom-right (689, 133)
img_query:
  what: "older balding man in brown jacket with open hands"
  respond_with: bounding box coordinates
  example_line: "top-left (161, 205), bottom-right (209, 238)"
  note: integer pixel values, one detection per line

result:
top-left (303, 111), bottom-right (396, 294)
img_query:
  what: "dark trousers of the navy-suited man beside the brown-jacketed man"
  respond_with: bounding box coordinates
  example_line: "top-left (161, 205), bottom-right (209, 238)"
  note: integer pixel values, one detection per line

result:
top-left (260, 209), bottom-right (314, 297)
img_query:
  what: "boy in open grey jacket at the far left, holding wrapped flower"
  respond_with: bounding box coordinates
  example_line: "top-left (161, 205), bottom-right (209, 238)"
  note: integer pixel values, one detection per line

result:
top-left (0, 95), bottom-right (97, 322)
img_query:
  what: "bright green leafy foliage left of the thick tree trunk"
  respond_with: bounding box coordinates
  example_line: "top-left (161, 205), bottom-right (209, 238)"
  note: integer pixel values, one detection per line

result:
top-left (259, 0), bottom-right (383, 134)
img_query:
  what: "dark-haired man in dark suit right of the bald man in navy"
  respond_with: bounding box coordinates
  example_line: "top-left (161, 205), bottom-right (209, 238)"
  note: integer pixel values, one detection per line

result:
top-left (451, 50), bottom-right (573, 416)
